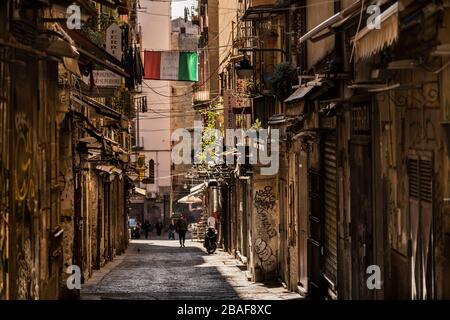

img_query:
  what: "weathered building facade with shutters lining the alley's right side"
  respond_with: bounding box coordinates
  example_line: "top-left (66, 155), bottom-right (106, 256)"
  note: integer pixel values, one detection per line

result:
top-left (210, 1), bottom-right (449, 299)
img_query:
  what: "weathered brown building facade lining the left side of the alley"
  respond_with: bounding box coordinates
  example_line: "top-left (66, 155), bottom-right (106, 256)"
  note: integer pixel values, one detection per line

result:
top-left (0, 1), bottom-right (140, 299)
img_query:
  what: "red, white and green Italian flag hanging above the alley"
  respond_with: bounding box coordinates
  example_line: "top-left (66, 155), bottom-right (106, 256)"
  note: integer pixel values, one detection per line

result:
top-left (144, 51), bottom-right (197, 81)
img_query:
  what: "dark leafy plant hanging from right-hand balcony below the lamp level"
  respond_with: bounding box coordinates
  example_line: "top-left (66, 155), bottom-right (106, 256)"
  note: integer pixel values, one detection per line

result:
top-left (269, 62), bottom-right (297, 101)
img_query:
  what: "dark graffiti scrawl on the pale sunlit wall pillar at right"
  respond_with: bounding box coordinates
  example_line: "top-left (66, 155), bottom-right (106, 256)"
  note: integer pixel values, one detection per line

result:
top-left (254, 186), bottom-right (277, 239)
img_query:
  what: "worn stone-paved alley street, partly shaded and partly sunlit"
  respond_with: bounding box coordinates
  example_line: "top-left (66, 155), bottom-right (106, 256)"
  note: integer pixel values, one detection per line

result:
top-left (81, 232), bottom-right (301, 300)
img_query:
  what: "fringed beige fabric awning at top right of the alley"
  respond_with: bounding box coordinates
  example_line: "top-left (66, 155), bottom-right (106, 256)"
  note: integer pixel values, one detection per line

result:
top-left (352, 2), bottom-right (402, 61)
